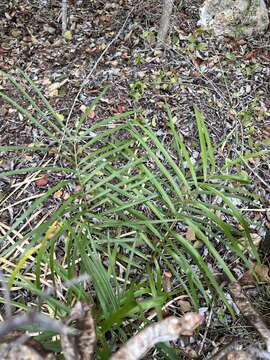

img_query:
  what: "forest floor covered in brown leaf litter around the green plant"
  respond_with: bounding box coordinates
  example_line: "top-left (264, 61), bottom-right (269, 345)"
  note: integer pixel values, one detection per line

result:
top-left (0, 0), bottom-right (270, 358)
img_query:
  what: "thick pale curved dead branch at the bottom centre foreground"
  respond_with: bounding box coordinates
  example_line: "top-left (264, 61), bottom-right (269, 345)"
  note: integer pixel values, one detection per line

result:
top-left (111, 313), bottom-right (203, 360)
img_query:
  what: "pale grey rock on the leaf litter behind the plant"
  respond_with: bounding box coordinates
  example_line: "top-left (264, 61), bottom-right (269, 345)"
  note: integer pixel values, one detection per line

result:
top-left (198, 0), bottom-right (269, 38)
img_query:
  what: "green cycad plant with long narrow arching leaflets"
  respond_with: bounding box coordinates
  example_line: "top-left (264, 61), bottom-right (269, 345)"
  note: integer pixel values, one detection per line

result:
top-left (0, 71), bottom-right (259, 358)
